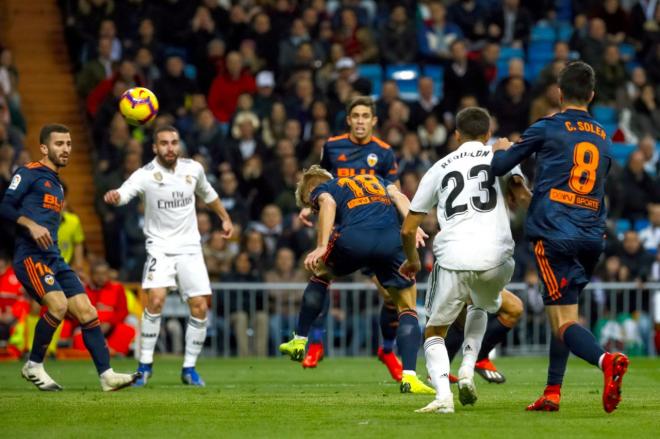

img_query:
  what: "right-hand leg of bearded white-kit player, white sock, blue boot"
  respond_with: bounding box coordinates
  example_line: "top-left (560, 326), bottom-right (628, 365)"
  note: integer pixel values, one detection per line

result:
top-left (181, 295), bottom-right (208, 387)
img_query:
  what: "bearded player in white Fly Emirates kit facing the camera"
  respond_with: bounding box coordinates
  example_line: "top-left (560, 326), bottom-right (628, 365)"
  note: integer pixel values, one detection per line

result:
top-left (104, 126), bottom-right (232, 386)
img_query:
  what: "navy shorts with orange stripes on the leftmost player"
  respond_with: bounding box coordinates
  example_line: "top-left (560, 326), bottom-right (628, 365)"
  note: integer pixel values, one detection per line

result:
top-left (14, 254), bottom-right (85, 303)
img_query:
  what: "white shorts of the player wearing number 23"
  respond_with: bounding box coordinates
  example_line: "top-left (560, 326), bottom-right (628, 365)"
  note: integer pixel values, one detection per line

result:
top-left (426, 258), bottom-right (515, 326)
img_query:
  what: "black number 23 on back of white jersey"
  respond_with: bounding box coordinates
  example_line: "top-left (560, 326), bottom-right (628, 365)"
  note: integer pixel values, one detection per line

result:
top-left (442, 165), bottom-right (497, 219)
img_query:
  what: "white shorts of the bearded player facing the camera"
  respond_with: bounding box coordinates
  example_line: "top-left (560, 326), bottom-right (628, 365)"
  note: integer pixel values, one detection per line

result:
top-left (142, 251), bottom-right (211, 300)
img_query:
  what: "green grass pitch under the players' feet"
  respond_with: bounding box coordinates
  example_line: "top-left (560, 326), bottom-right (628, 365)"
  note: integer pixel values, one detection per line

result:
top-left (0, 358), bottom-right (660, 439)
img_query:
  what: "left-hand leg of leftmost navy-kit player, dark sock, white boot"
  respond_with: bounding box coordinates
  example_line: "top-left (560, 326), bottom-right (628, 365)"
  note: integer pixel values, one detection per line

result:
top-left (21, 292), bottom-right (67, 391)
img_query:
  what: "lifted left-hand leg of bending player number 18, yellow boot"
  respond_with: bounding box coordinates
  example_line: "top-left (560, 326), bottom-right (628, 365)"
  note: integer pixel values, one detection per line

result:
top-left (280, 276), bottom-right (330, 361)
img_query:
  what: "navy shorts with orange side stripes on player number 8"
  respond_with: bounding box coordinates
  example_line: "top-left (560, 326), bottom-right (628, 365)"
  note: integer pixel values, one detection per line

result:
top-left (534, 239), bottom-right (605, 305)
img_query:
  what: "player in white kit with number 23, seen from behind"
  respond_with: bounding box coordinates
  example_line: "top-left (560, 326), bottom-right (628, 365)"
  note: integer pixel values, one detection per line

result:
top-left (401, 107), bottom-right (526, 413)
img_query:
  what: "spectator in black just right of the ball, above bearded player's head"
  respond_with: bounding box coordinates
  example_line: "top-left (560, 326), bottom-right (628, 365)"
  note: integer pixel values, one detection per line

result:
top-left (154, 56), bottom-right (196, 116)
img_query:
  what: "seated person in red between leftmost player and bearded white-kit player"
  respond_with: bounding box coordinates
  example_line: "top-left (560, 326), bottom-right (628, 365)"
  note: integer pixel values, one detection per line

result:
top-left (73, 261), bottom-right (135, 355)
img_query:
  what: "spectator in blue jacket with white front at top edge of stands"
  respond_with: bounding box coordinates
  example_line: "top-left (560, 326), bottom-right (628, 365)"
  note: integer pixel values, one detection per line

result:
top-left (420, 1), bottom-right (463, 63)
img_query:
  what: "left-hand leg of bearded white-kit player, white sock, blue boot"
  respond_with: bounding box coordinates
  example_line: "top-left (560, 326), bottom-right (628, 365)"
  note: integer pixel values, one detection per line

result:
top-left (135, 288), bottom-right (167, 387)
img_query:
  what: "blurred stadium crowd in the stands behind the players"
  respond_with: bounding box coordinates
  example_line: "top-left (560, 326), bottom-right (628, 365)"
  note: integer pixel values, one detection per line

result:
top-left (0, 0), bottom-right (660, 353)
